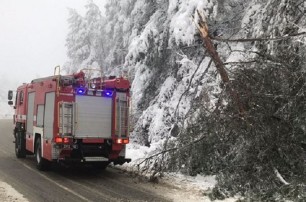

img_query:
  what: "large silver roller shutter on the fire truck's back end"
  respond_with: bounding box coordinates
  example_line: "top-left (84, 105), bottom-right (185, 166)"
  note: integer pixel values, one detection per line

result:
top-left (75, 95), bottom-right (112, 138)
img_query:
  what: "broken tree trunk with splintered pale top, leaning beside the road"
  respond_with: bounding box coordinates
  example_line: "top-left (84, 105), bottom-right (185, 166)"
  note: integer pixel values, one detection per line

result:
top-left (195, 10), bottom-right (245, 116)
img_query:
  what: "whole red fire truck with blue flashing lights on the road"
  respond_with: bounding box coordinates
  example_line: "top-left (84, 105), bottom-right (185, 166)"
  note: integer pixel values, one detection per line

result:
top-left (8, 71), bottom-right (131, 170)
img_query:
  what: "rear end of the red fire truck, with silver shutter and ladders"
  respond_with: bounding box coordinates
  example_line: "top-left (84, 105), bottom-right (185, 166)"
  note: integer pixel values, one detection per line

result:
top-left (52, 72), bottom-right (131, 168)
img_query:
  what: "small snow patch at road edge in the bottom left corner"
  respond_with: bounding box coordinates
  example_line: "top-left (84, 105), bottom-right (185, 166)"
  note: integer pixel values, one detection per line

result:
top-left (0, 181), bottom-right (28, 202)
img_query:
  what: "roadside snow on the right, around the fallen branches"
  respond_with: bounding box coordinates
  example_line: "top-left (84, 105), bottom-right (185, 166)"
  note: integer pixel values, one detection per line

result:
top-left (118, 143), bottom-right (238, 202)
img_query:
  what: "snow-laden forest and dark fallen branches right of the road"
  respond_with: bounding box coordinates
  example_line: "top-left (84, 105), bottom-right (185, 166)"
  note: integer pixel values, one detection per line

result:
top-left (64, 0), bottom-right (306, 201)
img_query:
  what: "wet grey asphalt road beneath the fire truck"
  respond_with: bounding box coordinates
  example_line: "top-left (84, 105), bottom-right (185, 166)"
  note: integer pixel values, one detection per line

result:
top-left (0, 120), bottom-right (169, 202)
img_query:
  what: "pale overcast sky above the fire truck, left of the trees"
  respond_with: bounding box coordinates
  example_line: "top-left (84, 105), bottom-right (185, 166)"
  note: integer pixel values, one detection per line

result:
top-left (0, 0), bottom-right (107, 89)
